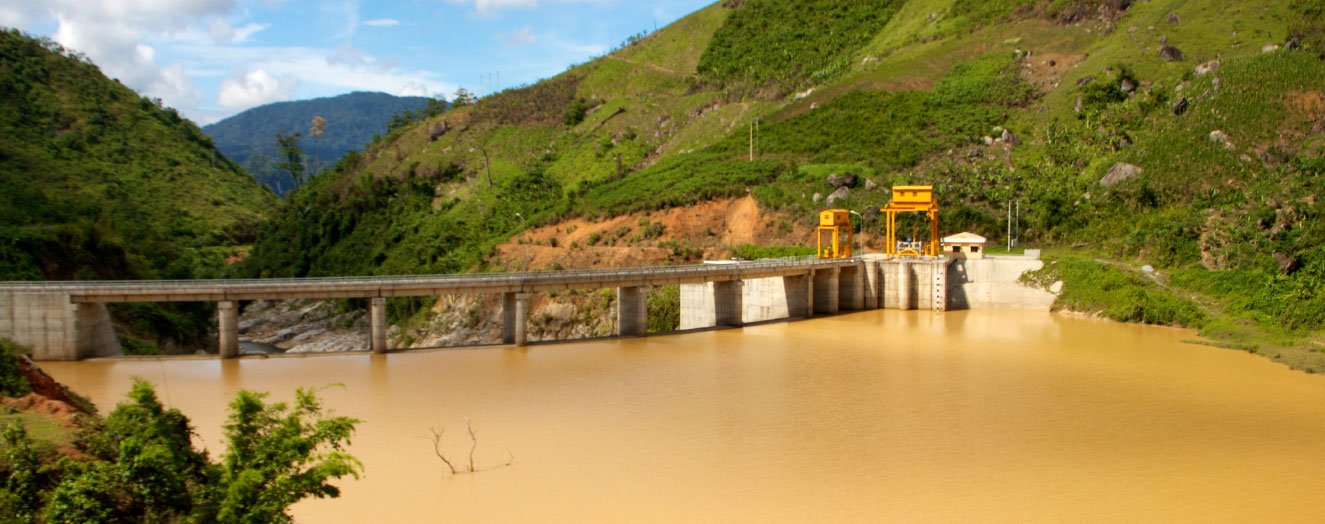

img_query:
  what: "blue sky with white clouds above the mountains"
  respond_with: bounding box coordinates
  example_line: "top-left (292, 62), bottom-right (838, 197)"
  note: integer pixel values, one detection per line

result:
top-left (0, 0), bottom-right (714, 125)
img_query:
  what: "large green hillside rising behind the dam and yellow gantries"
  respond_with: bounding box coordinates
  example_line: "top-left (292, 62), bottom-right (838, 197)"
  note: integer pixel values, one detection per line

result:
top-left (245, 0), bottom-right (1325, 369)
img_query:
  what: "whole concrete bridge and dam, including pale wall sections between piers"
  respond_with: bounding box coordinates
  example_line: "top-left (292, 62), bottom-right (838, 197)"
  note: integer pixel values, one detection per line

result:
top-left (0, 256), bottom-right (969, 360)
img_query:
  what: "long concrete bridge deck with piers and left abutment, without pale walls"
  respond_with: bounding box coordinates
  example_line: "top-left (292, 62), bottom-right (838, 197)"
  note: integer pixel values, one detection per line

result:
top-left (0, 256), bottom-right (861, 360)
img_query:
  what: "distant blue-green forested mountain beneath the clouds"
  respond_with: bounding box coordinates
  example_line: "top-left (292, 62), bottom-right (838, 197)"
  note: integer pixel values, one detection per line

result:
top-left (203, 92), bottom-right (445, 195)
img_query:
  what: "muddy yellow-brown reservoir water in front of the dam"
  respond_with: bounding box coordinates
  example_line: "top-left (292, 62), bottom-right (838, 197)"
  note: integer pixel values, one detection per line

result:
top-left (41, 310), bottom-right (1325, 523)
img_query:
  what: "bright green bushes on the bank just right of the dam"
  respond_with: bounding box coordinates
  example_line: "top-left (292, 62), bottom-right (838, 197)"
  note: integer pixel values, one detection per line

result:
top-left (1022, 257), bottom-right (1208, 328)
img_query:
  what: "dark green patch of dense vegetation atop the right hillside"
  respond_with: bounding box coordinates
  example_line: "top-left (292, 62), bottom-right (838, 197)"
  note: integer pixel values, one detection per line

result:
top-left (698, 0), bottom-right (902, 92)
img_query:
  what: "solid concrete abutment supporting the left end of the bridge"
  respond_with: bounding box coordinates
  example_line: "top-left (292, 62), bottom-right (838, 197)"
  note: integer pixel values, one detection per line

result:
top-left (0, 292), bottom-right (122, 361)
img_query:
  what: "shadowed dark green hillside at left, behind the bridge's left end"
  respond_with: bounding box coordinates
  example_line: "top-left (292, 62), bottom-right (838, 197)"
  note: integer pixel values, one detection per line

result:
top-left (0, 29), bottom-right (278, 352)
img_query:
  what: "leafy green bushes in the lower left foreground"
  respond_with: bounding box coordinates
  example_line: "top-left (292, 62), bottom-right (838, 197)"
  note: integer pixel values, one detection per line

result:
top-left (0, 381), bottom-right (362, 523)
